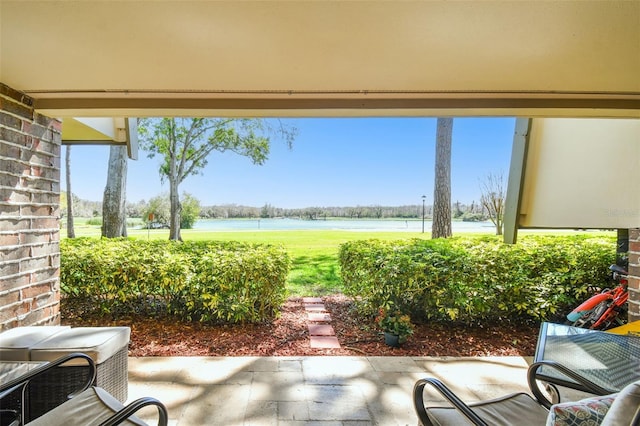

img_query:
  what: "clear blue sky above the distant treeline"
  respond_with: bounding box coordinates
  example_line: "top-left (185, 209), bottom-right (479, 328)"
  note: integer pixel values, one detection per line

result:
top-left (61, 118), bottom-right (515, 208)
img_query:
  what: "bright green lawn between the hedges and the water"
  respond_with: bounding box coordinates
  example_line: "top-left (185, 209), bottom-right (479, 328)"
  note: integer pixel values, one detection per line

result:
top-left (62, 219), bottom-right (608, 296)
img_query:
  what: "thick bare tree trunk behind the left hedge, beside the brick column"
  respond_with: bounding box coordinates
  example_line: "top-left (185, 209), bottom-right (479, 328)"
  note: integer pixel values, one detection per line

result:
top-left (102, 145), bottom-right (127, 238)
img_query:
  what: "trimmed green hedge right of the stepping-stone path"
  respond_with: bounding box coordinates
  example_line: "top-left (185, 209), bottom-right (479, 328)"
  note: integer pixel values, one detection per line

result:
top-left (339, 236), bottom-right (615, 323)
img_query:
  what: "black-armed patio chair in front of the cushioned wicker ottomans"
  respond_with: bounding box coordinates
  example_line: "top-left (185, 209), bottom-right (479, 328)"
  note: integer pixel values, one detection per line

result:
top-left (0, 353), bottom-right (168, 426)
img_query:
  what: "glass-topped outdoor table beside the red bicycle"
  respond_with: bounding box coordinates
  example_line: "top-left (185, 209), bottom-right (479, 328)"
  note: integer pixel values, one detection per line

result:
top-left (534, 322), bottom-right (640, 393)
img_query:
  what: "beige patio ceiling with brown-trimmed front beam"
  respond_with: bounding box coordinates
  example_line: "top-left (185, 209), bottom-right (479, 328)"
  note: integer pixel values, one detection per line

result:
top-left (0, 0), bottom-right (640, 117)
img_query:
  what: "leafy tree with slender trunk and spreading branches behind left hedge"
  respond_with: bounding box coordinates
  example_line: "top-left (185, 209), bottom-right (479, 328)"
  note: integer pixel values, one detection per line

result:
top-left (138, 118), bottom-right (296, 240)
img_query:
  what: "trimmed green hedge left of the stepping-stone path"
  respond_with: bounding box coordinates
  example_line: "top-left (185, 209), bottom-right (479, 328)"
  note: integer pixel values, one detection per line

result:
top-left (60, 238), bottom-right (290, 322)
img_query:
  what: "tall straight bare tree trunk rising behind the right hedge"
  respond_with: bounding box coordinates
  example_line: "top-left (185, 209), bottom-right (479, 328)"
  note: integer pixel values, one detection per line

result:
top-left (431, 118), bottom-right (453, 238)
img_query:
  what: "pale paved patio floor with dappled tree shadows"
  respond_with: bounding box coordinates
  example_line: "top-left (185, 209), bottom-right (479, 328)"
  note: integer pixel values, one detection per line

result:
top-left (129, 356), bottom-right (531, 426)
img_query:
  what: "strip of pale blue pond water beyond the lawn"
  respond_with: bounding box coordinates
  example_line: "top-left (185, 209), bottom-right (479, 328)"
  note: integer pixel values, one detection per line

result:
top-left (194, 218), bottom-right (495, 233)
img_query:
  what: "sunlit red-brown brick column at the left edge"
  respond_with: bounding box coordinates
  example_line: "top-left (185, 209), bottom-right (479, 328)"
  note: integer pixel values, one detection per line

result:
top-left (0, 83), bottom-right (62, 331)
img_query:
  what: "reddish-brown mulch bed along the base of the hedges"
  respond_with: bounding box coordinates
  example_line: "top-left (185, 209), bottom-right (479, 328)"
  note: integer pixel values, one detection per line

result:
top-left (62, 295), bottom-right (538, 356)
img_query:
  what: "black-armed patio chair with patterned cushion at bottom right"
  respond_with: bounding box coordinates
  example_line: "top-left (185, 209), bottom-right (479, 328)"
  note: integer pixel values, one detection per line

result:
top-left (413, 361), bottom-right (640, 426)
